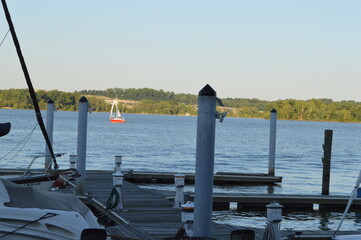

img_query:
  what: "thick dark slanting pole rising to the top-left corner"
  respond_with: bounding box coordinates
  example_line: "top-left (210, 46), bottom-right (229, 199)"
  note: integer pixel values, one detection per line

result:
top-left (1, 0), bottom-right (59, 169)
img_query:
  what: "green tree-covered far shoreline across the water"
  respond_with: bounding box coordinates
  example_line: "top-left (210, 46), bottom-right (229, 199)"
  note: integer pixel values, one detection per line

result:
top-left (0, 88), bottom-right (361, 123)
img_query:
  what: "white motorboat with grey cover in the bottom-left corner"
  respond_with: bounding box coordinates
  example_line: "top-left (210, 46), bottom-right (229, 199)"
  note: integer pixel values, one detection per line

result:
top-left (0, 179), bottom-right (105, 240)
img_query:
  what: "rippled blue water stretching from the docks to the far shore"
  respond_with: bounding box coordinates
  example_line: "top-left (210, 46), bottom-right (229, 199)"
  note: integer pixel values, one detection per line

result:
top-left (0, 109), bottom-right (361, 230)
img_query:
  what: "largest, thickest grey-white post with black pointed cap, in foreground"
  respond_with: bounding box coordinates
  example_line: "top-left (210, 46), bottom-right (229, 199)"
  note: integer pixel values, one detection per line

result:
top-left (194, 84), bottom-right (217, 238)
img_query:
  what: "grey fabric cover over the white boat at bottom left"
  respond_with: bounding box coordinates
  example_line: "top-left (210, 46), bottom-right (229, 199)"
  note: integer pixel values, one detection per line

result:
top-left (1, 179), bottom-right (90, 216)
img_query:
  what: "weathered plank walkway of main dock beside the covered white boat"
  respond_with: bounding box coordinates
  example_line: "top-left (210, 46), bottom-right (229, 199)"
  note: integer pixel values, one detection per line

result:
top-left (86, 171), bottom-right (236, 240)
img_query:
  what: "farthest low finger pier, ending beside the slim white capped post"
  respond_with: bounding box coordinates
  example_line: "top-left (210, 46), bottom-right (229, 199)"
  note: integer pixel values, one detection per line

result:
top-left (123, 171), bottom-right (282, 185)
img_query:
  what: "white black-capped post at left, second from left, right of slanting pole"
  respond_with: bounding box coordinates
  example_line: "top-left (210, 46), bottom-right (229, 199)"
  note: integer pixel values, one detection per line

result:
top-left (76, 96), bottom-right (89, 195)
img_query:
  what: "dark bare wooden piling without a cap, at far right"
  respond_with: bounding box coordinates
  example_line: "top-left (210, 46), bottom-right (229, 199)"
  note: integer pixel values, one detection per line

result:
top-left (322, 130), bottom-right (333, 195)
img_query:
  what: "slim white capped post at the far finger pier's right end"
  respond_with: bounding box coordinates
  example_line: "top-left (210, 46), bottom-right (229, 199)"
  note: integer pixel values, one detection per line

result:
top-left (268, 108), bottom-right (277, 176)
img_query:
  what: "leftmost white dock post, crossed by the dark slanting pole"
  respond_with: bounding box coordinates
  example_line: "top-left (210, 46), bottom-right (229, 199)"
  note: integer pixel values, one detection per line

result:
top-left (44, 99), bottom-right (55, 173)
